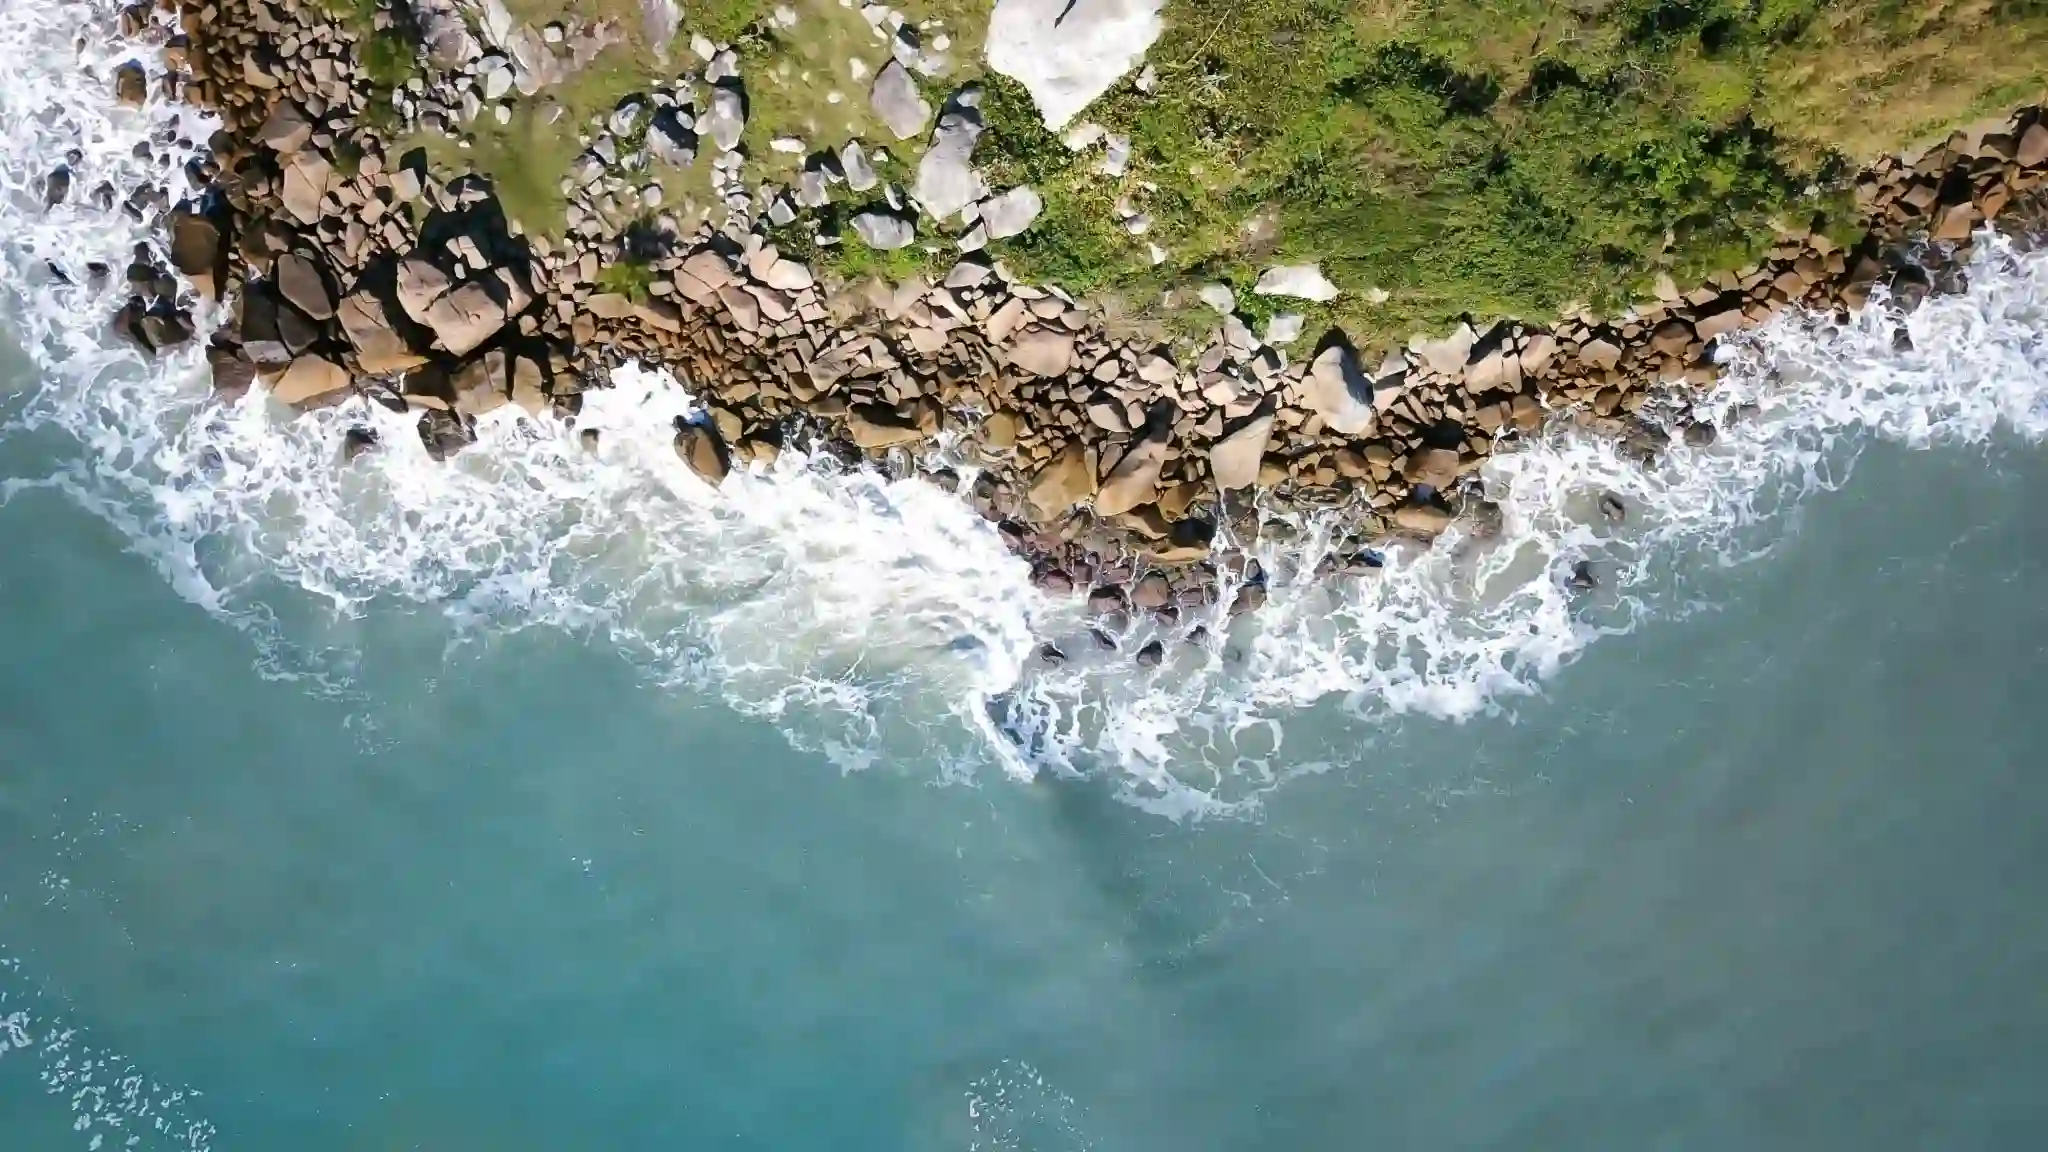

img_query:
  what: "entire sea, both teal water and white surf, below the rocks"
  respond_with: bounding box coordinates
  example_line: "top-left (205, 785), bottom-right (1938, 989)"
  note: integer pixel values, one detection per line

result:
top-left (12, 0), bottom-right (2048, 1152)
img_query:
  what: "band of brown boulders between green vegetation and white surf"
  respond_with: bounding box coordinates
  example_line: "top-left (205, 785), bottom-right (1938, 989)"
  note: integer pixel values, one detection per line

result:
top-left (64, 0), bottom-right (2048, 615)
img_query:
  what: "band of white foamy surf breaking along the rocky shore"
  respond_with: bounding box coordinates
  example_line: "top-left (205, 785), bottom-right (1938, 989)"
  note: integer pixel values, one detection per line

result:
top-left (0, 0), bottom-right (2048, 818)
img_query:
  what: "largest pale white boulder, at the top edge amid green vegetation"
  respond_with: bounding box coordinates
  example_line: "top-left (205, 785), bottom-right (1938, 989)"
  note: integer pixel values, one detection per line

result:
top-left (985, 0), bottom-right (1163, 131)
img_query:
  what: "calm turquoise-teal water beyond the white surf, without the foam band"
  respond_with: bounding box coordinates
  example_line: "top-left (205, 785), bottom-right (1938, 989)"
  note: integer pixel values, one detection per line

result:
top-left (12, 362), bottom-right (2048, 1150)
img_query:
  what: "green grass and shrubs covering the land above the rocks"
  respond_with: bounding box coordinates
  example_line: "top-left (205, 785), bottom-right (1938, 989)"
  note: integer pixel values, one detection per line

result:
top-left (356, 0), bottom-right (2048, 344)
